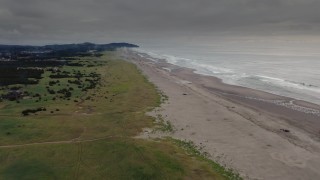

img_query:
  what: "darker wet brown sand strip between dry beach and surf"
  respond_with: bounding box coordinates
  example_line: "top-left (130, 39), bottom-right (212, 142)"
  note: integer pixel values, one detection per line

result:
top-left (130, 51), bottom-right (320, 138)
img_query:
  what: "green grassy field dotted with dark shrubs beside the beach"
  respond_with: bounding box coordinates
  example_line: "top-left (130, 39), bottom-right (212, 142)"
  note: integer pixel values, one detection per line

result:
top-left (0, 53), bottom-right (240, 180)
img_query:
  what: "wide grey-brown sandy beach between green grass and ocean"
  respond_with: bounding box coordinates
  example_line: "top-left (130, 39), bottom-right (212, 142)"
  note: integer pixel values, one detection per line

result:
top-left (119, 50), bottom-right (320, 180)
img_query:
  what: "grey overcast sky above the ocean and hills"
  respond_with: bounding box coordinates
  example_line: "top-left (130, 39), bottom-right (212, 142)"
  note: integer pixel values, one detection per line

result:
top-left (0, 0), bottom-right (320, 44)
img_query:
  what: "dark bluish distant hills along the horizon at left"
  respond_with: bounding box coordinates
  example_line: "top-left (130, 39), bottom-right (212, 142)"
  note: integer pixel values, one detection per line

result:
top-left (0, 42), bottom-right (139, 52)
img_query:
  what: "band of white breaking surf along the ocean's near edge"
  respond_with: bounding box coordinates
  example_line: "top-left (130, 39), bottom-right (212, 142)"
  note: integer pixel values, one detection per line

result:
top-left (132, 49), bottom-right (320, 104)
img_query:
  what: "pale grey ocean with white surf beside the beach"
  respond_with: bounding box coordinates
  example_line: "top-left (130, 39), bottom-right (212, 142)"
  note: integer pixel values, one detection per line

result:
top-left (135, 41), bottom-right (320, 105)
